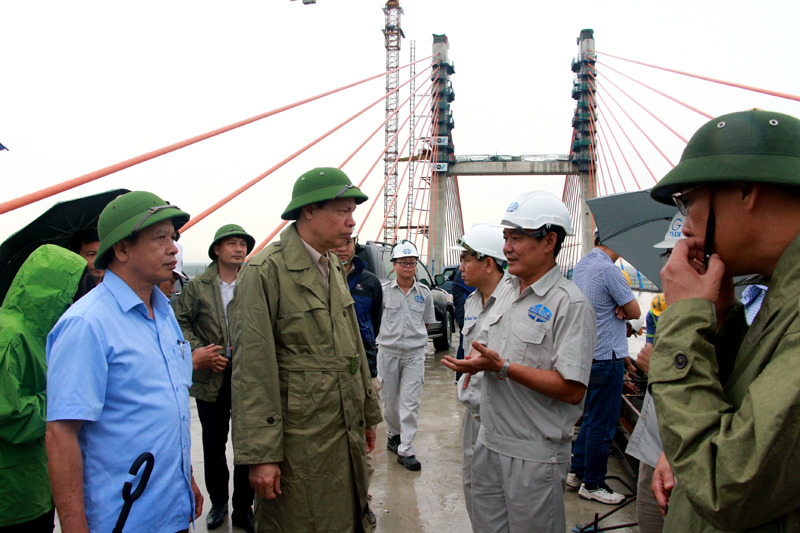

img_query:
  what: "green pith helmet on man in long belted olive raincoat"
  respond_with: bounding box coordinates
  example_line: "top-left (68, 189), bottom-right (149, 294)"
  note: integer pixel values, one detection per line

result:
top-left (281, 167), bottom-right (368, 220)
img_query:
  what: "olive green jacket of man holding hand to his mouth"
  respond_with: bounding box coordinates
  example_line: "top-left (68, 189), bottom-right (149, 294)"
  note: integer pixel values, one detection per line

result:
top-left (650, 236), bottom-right (800, 533)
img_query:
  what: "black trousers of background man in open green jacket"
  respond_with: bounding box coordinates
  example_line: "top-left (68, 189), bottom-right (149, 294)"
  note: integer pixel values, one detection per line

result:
top-left (197, 365), bottom-right (255, 514)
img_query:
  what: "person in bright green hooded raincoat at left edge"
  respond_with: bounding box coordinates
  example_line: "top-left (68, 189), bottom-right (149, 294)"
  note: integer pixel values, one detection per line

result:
top-left (0, 244), bottom-right (94, 533)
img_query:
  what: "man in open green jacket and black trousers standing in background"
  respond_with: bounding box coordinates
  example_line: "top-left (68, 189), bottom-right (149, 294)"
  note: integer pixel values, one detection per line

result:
top-left (175, 224), bottom-right (255, 532)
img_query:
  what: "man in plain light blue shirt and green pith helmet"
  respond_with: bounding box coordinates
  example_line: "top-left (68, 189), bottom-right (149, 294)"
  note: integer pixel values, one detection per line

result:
top-left (46, 191), bottom-right (203, 533)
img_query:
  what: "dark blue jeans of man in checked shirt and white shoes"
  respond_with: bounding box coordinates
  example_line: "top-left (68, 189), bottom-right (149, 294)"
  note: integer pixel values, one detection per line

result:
top-left (570, 357), bottom-right (625, 487)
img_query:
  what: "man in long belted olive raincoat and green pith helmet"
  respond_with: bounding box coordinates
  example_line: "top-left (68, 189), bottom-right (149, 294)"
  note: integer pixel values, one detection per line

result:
top-left (229, 168), bottom-right (381, 533)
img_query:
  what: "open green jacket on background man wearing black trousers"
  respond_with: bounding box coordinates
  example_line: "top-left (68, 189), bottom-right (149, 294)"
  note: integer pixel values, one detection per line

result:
top-left (174, 261), bottom-right (228, 402)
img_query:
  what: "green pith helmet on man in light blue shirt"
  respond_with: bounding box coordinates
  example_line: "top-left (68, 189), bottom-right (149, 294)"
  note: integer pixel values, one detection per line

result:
top-left (94, 191), bottom-right (189, 270)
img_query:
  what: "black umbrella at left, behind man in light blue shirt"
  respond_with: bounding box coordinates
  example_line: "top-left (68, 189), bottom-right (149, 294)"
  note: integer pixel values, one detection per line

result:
top-left (0, 189), bottom-right (130, 302)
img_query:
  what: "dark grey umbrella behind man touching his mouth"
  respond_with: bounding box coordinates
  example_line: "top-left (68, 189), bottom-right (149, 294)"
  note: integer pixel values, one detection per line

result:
top-left (586, 190), bottom-right (678, 289)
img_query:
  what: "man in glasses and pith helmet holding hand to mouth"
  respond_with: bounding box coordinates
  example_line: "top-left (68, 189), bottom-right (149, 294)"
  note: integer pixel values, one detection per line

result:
top-left (650, 110), bottom-right (800, 532)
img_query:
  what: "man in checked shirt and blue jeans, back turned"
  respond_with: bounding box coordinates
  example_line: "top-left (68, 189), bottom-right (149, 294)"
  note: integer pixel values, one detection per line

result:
top-left (567, 232), bottom-right (641, 505)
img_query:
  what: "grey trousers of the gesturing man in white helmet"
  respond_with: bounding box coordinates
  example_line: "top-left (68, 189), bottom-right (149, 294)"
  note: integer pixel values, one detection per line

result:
top-left (472, 441), bottom-right (569, 533)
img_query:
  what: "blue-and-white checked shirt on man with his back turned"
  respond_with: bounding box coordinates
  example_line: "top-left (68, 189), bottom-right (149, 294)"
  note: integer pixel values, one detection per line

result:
top-left (572, 248), bottom-right (634, 361)
